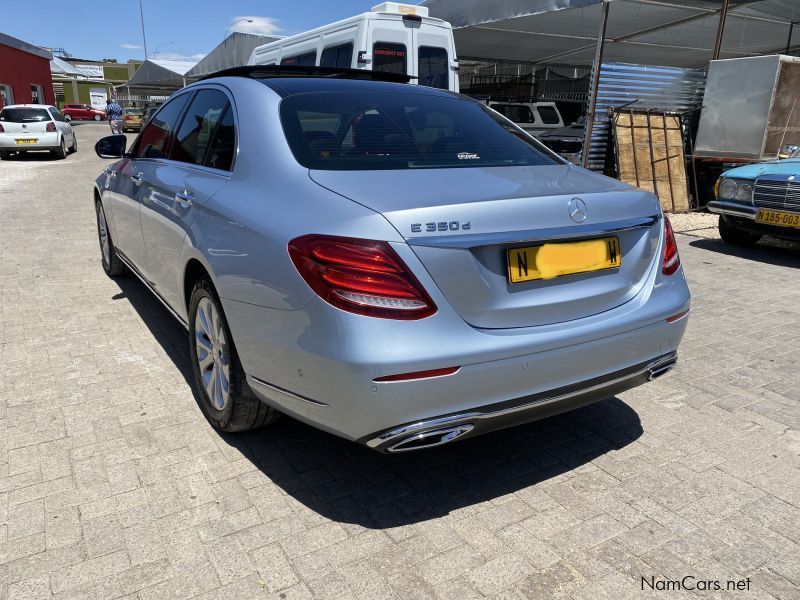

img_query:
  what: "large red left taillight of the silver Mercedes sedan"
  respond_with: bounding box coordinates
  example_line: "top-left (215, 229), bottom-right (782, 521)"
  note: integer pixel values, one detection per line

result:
top-left (289, 235), bottom-right (436, 319)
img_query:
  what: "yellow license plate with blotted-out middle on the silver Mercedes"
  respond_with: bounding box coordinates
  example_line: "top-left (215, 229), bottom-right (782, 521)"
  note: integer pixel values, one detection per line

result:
top-left (506, 237), bottom-right (622, 283)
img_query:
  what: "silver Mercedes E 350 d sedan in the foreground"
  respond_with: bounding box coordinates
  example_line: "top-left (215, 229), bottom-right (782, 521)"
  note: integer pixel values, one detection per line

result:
top-left (94, 67), bottom-right (689, 452)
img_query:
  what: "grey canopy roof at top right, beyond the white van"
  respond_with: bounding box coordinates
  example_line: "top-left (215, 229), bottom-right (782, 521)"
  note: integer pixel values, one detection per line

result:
top-left (423, 0), bottom-right (800, 67)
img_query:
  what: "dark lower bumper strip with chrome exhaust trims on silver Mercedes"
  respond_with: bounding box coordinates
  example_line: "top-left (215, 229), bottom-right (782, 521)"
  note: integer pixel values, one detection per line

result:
top-left (359, 352), bottom-right (677, 453)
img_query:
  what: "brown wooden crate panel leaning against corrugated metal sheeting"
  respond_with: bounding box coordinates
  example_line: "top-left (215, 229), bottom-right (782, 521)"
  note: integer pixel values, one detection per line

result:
top-left (611, 110), bottom-right (689, 212)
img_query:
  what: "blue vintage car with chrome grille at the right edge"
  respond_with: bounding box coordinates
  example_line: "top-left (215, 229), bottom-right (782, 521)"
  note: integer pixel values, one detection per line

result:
top-left (708, 157), bottom-right (800, 246)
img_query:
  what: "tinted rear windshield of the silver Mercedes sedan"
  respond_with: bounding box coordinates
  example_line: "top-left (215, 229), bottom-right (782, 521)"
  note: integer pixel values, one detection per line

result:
top-left (281, 92), bottom-right (558, 171)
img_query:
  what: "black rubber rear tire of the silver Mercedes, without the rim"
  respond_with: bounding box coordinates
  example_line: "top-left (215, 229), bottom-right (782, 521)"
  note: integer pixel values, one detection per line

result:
top-left (189, 277), bottom-right (280, 432)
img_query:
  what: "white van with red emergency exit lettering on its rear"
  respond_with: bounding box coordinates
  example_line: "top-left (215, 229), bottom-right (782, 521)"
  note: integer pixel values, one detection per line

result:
top-left (247, 2), bottom-right (458, 92)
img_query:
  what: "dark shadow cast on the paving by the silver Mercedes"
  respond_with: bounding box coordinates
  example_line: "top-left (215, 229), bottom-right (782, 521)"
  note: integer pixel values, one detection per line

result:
top-left (113, 276), bottom-right (642, 529)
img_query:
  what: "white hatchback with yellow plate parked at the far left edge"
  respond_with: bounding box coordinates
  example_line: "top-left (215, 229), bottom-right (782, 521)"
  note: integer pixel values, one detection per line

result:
top-left (0, 104), bottom-right (78, 159)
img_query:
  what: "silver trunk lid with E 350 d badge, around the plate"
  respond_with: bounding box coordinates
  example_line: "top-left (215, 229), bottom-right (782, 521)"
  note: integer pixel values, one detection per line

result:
top-left (310, 165), bottom-right (661, 328)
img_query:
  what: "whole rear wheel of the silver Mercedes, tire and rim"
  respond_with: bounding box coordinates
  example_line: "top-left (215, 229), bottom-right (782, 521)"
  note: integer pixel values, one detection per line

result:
top-left (189, 278), bottom-right (279, 432)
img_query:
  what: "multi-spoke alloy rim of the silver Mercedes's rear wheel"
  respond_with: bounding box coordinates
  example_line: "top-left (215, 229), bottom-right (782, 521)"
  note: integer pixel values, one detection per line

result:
top-left (194, 298), bottom-right (231, 411)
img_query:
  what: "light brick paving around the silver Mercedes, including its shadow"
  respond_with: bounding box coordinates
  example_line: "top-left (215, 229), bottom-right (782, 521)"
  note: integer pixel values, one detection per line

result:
top-left (0, 125), bottom-right (800, 600)
